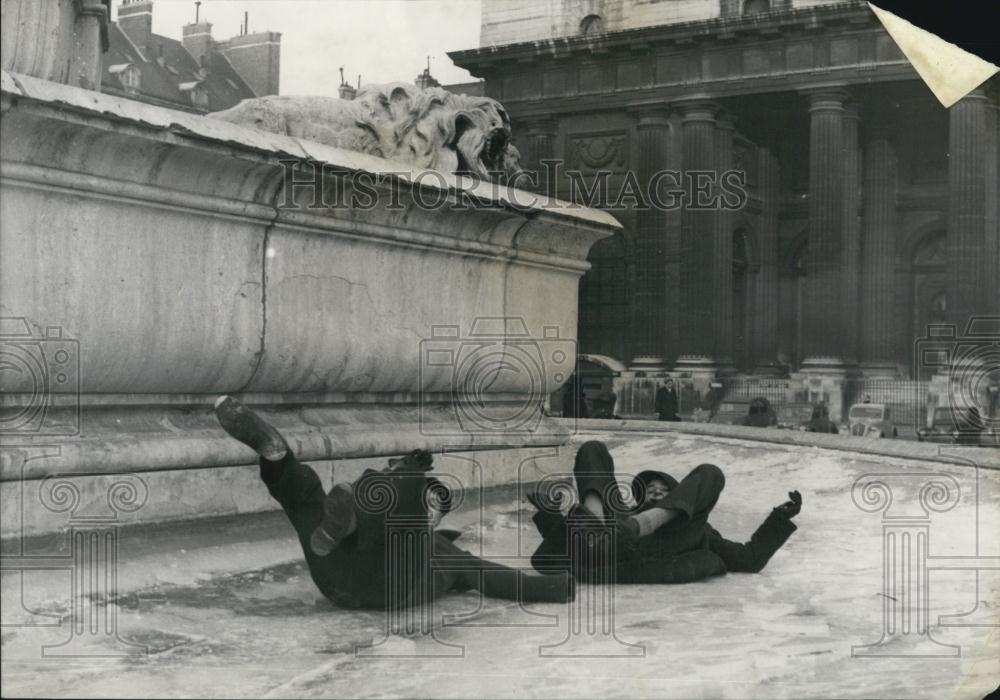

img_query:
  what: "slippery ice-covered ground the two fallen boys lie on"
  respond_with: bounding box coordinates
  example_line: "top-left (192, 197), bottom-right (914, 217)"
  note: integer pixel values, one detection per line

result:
top-left (2, 435), bottom-right (1000, 700)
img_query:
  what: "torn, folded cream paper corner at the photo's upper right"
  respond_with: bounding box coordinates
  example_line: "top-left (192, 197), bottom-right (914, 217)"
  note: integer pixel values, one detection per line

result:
top-left (868, 3), bottom-right (1000, 107)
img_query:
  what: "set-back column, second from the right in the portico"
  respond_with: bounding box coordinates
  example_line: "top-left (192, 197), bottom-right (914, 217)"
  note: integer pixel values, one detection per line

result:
top-left (861, 134), bottom-right (898, 376)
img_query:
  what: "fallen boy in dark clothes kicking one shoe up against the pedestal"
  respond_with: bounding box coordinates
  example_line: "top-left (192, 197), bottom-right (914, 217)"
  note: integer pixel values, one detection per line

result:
top-left (215, 396), bottom-right (574, 609)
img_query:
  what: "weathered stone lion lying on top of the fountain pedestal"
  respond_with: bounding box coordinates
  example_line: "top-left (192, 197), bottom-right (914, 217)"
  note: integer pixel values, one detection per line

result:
top-left (209, 83), bottom-right (524, 186)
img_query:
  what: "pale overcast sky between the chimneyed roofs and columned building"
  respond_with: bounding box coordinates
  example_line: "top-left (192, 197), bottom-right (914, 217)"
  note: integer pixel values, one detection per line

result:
top-left (114, 0), bottom-right (480, 95)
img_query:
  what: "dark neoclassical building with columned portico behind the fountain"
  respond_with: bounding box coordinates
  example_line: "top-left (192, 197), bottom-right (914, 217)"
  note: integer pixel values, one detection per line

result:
top-left (450, 0), bottom-right (1000, 402)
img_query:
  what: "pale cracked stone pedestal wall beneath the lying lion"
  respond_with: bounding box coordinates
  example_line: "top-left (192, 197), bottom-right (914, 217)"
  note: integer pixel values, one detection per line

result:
top-left (0, 73), bottom-right (620, 479)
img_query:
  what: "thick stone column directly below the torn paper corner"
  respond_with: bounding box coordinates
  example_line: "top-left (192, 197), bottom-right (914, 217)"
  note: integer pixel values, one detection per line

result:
top-left (947, 89), bottom-right (997, 332)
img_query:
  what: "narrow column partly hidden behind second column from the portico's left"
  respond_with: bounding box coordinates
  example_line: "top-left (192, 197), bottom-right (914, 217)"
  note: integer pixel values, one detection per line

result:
top-left (711, 112), bottom-right (736, 371)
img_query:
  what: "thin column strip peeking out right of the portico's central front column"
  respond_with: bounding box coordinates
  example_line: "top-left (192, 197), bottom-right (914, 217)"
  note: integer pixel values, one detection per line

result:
top-left (843, 103), bottom-right (867, 365)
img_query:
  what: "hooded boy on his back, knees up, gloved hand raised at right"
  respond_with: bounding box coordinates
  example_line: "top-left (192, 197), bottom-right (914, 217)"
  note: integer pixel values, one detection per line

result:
top-left (529, 440), bottom-right (802, 583)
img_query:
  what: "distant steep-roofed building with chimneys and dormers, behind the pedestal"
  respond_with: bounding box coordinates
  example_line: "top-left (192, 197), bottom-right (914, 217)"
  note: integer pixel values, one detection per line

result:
top-left (101, 0), bottom-right (281, 113)
